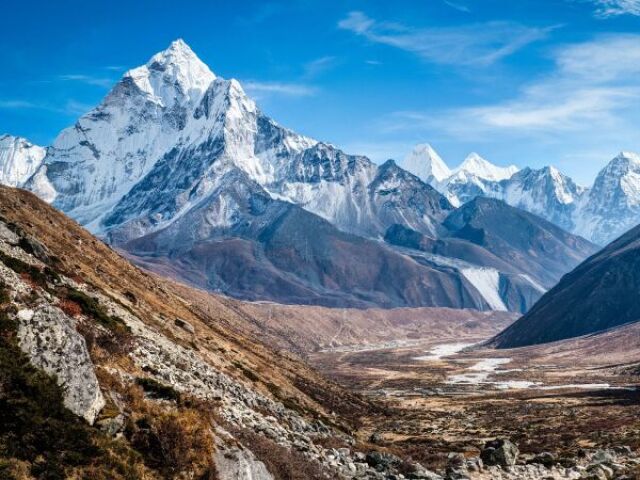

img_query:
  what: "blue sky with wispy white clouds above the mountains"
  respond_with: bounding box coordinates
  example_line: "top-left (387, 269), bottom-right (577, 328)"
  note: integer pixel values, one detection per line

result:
top-left (0, 0), bottom-right (640, 183)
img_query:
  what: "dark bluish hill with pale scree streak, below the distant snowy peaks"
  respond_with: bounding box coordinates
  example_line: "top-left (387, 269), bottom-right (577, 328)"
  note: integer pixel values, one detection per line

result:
top-left (385, 197), bottom-right (595, 312)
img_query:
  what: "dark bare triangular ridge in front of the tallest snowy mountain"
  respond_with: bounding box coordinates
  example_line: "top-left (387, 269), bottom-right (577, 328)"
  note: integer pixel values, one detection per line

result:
top-left (115, 171), bottom-right (488, 310)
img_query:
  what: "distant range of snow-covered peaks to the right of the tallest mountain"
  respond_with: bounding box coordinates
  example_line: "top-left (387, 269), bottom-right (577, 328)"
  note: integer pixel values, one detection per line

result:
top-left (403, 144), bottom-right (640, 245)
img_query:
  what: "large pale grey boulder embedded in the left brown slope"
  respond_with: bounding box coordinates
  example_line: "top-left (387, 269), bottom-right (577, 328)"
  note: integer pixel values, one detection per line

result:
top-left (18, 305), bottom-right (105, 424)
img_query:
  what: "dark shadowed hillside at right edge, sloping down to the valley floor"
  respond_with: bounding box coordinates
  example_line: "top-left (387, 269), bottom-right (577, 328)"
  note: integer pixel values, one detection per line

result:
top-left (494, 223), bottom-right (640, 348)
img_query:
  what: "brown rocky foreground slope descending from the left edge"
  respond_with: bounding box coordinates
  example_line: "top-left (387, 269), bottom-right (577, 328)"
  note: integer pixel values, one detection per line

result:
top-left (0, 187), bottom-right (450, 480)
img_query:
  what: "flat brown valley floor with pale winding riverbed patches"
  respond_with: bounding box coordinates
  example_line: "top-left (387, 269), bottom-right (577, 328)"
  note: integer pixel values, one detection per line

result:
top-left (309, 326), bottom-right (640, 478)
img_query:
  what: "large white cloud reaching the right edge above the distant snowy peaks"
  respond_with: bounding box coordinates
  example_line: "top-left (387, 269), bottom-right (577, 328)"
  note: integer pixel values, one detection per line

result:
top-left (412, 35), bottom-right (640, 136)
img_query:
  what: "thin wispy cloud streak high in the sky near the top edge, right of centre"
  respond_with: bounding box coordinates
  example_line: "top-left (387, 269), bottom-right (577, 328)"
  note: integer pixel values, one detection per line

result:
top-left (338, 11), bottom-right (555, 66)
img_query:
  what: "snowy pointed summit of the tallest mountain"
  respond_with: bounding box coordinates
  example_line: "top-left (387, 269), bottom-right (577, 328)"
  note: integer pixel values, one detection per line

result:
top-left (124, 39), bottom-right (216, 107)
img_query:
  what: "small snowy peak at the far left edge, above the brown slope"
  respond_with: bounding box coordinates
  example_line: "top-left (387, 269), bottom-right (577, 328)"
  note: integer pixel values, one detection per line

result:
top-left (0, 135), bottom-right (46, 187)
